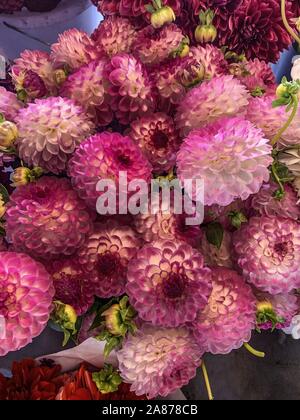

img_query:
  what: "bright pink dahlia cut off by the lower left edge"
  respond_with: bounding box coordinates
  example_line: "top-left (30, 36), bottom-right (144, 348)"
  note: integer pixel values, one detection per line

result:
top-left (0, 252), bottom-right (54, 356)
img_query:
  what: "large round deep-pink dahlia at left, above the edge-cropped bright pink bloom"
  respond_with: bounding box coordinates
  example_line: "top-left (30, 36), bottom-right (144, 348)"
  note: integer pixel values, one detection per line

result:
top-left (6, 176), bottom-right (92, 260)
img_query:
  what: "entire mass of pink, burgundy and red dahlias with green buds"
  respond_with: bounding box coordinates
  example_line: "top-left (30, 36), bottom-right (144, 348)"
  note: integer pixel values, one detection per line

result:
top-left (0, 0), bottom-right (300, 399)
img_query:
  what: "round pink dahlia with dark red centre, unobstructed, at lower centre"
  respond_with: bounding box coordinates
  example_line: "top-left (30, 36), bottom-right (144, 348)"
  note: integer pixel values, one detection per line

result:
top-left (126, 240), bottom-right (211, 327)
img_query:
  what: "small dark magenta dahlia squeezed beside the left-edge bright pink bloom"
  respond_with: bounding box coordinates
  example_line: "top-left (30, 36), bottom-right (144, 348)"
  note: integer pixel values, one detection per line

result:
top-left (47, 257), bottom-right (95, 315)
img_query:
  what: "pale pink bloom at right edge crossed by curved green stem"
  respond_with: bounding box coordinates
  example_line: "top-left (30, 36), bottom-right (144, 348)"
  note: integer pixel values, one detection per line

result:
top-left (246, 95), bottom-right (300, 146)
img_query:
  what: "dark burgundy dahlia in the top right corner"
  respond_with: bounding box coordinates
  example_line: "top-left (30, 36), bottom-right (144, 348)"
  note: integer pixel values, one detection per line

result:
top-left (221, 0), bottom-right (292, 63)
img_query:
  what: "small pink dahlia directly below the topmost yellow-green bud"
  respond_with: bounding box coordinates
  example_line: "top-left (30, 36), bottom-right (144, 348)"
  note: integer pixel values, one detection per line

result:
top-left (133, 23), bottom-right (185, 65)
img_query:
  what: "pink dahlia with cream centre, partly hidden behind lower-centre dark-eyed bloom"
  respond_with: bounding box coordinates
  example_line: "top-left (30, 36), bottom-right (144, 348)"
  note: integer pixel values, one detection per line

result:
top-left (192, 267), bottom-right (256, 354)
